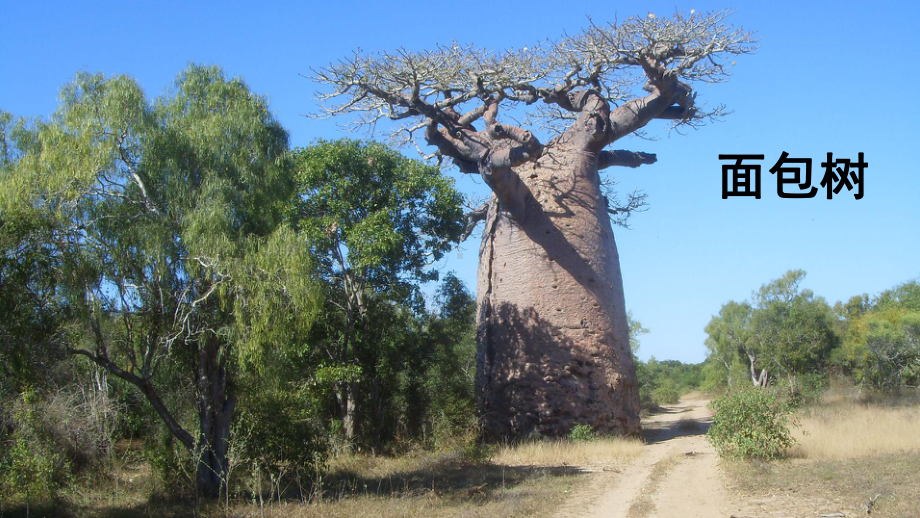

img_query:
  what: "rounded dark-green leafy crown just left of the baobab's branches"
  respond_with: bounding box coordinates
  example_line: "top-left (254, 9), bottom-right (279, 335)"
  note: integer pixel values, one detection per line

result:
top-left (291, 140), bottom-right (463, 282)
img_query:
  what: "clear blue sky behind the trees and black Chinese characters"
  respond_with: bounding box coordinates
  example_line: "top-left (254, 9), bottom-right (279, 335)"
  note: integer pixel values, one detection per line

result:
top-left (0, 0), bottom-right (920, 362)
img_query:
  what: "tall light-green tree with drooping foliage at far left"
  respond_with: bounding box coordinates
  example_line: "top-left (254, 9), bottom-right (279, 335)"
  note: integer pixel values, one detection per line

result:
top-left (0, 66), bottom-right (319, 497)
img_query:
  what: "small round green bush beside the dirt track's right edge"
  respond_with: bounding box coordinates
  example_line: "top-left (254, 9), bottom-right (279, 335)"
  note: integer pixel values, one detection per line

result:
top-left (706, 387), bottom-right (795, 459)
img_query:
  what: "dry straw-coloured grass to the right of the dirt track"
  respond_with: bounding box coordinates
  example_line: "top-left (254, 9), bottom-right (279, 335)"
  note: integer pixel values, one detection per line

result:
top-left (724, 393), bottom-right (920, 518)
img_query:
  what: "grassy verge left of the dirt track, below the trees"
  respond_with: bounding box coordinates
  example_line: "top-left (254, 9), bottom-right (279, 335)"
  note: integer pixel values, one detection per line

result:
top-left (2, 438), bottom-right (643, 518)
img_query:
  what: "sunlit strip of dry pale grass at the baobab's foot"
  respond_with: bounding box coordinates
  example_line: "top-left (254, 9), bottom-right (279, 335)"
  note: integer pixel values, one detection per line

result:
top-left (492, 437), bottom-right (644, 467)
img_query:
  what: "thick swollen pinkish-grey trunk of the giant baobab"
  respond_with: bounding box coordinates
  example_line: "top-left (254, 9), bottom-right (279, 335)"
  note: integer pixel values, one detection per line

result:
top-left (476, 143), bottom-right (640, 438)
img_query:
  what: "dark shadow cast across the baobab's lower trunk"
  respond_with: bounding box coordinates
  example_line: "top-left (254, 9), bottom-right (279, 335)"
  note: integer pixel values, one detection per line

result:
top-left (477, 303), bottom-right (638, 440)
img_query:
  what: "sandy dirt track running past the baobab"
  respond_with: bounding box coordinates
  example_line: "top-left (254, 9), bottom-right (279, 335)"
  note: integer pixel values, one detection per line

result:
top-left (572, 399), bottom-right (741, 518)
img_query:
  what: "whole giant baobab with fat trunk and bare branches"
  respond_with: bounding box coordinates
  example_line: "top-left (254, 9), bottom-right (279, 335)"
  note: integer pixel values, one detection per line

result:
top-left (313, 11), bottom-right (755, 437)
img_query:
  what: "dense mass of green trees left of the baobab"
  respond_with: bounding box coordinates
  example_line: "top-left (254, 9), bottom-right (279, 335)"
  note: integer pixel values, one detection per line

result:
top-left (0, 66), bottom-right (475, 508)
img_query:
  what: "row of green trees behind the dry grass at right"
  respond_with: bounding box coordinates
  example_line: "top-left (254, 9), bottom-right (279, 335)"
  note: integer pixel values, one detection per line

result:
top-left (703, 270), bottom-right (920, 399)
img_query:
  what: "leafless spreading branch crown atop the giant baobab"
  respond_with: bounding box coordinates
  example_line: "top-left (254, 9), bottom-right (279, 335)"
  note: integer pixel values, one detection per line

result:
top-left (313, 11), bottom-right (756, 181)
